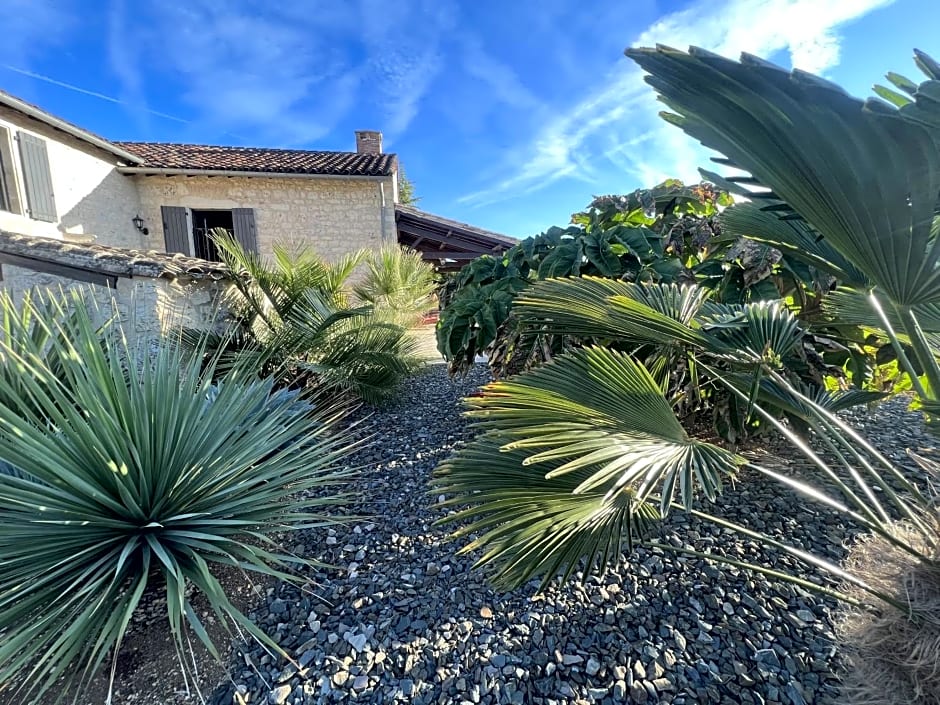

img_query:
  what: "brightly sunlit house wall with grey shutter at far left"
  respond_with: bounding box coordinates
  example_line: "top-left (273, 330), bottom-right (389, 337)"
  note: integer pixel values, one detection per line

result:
top-left (0, 106), bottom-right (145, 249)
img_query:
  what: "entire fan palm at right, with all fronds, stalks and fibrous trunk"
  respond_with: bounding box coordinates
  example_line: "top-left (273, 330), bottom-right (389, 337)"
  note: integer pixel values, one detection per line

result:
top-left (434, 47), bottom-right (940, 704)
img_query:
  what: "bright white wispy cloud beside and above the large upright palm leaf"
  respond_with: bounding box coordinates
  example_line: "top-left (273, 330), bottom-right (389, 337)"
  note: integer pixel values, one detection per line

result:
top-left (459, 0), bottom-right (893, 206)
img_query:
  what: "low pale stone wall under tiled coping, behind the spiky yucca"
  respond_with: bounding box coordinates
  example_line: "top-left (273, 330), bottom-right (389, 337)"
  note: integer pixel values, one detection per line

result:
top-left (0, 264), bottom-right (230, 343)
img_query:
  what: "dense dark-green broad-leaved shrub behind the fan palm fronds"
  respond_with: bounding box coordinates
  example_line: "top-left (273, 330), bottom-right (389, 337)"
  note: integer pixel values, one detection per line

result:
top-left (437, 180), bottom-right (828, 376)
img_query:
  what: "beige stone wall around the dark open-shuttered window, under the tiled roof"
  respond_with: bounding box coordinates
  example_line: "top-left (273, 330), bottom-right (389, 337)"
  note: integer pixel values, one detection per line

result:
top-left (134, 175), bottom-right (396, 260)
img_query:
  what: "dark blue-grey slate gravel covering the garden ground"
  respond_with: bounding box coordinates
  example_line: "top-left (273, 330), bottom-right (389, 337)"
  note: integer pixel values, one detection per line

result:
top-left (210, 366), bottom-right (924, 705)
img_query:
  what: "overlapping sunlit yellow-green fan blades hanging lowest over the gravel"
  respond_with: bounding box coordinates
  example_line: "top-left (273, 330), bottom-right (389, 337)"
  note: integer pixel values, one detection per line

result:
top-left (433, 348), bottom-right (741, 584)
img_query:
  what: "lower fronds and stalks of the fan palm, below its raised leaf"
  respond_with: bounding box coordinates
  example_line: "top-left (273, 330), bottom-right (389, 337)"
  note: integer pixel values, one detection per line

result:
top-left (432, 278), bottom-right (930, 603)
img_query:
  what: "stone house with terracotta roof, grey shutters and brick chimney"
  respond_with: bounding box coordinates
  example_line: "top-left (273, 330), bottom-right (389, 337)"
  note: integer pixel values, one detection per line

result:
top-left (0, 86), bottom-right (514, 338)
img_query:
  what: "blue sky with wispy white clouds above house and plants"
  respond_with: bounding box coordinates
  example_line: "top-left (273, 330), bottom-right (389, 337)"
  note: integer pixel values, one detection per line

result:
top-left (0, 0), bottom-right (940, 237)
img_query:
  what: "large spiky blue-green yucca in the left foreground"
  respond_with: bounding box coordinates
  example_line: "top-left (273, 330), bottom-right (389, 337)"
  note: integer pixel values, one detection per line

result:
top-left (0, 294), bottom-right (350, 702)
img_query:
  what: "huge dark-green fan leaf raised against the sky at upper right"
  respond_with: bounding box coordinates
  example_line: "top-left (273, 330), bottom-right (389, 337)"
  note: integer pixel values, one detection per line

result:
top-left (627, 47), bottom-right (940, 410)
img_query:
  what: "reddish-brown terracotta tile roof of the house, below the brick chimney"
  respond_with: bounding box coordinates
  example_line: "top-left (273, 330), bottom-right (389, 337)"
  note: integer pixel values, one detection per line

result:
top-left (113, 142), bottom-right (396, 176)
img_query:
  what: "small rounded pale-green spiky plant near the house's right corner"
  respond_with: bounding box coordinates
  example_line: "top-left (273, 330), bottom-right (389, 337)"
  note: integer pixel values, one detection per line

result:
top-left (353, 245), bottom-right (437, 328)
